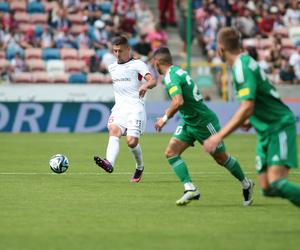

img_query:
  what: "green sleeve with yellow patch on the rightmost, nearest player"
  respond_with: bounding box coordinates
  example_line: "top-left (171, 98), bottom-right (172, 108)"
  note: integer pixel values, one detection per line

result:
top-left (234, 58), bottom-right (258, 101)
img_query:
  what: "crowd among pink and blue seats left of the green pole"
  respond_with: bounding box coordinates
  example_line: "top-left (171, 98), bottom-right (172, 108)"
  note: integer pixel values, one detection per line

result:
top-left (0, 0), bottom-right (159, 83)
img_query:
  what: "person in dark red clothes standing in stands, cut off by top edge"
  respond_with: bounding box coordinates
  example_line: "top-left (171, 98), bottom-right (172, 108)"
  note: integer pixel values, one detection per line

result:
top-left (158, 0), bottom-right (177, 28)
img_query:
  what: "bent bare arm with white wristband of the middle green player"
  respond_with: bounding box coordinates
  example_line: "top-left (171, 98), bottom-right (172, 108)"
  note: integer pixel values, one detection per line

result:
top-left (155, 94), bottom-right (184, 132)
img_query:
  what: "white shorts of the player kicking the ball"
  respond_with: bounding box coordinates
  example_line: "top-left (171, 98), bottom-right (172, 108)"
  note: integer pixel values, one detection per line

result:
top-left (107, 106), bottom-right (146, 138)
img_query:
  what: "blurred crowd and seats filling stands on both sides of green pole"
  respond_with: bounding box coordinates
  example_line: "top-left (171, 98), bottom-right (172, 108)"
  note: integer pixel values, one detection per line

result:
top-left (0, 0), bottom-right (300, 84)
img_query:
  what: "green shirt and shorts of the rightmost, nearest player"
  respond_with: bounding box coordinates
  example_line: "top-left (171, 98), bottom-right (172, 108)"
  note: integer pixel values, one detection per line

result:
top-left (232, 54), bottom-right (297, 173)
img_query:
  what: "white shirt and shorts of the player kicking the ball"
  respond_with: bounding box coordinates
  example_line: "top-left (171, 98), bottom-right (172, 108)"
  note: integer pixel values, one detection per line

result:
top-left (108, 59), bottom-right (150, 137)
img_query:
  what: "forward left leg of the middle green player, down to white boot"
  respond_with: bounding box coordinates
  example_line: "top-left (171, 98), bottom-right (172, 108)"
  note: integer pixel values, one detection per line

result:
top-left (165, 126), bottom-right (200, 206)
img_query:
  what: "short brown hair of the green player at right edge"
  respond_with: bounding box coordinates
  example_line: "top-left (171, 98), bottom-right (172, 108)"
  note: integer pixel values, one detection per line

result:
top-left (218, 27), bottom-right (241, 52)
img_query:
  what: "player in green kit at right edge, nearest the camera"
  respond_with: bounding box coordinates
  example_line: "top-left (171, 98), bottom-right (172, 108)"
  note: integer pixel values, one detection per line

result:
top-left (204, 27), bottom-right (300, 207)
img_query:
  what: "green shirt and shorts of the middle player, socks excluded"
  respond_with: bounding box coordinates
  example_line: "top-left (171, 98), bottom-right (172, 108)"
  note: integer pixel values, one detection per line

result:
top-left (163, 65), bottom-right (225, 152)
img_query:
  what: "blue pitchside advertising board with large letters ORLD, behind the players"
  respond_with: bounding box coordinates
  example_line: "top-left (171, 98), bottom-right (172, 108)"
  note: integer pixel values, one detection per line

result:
top-left (0, 101), bottom-right (300, 134)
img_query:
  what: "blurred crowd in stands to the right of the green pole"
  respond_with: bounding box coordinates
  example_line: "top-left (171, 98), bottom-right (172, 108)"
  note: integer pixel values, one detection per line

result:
top-left (192, 0), bottom-right (300, 84)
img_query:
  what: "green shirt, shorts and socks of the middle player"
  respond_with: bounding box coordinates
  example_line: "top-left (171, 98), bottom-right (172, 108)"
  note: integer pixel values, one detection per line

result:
top-left (163, 65), bottom-right (248, 191)
